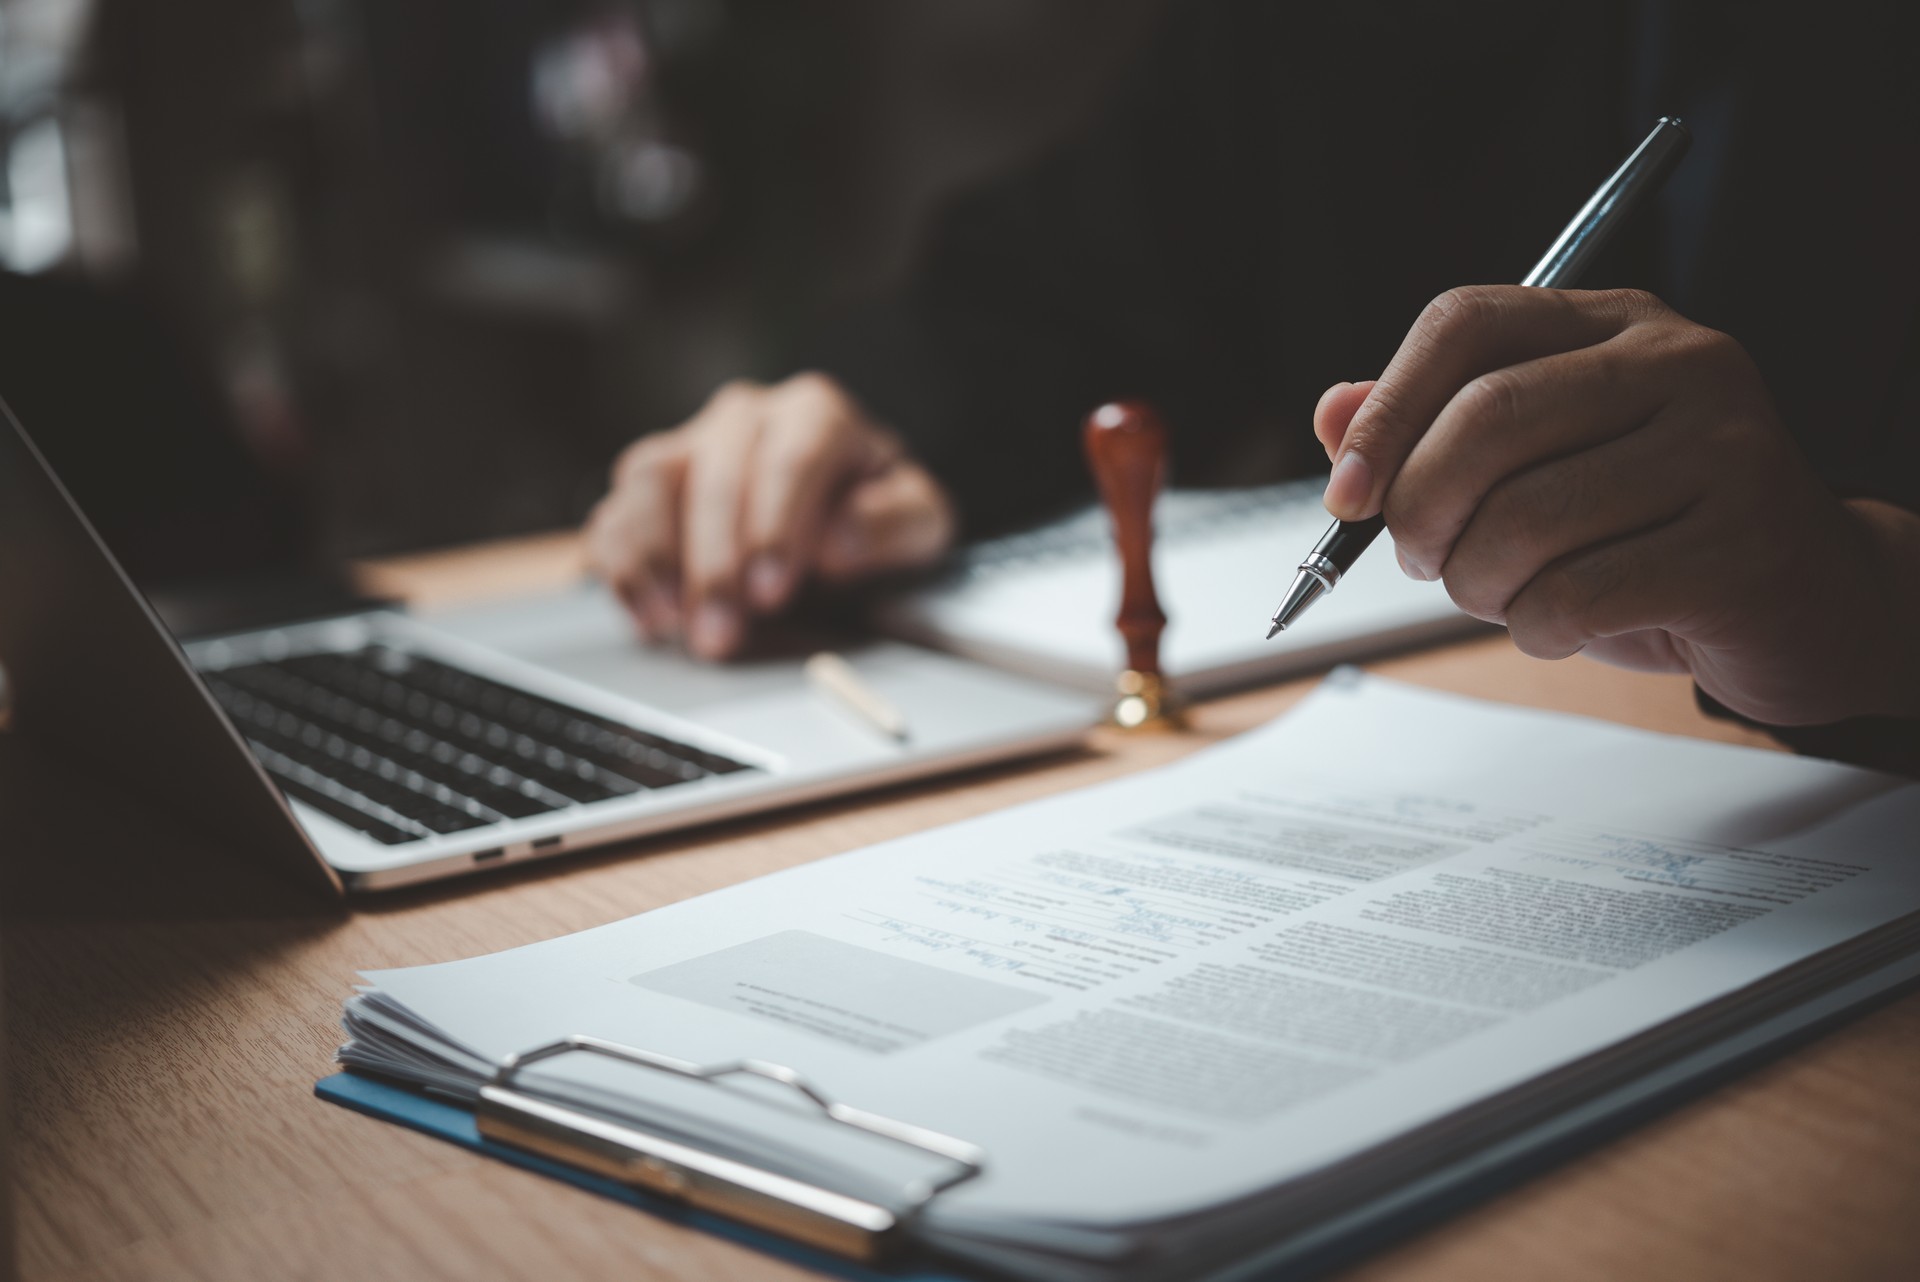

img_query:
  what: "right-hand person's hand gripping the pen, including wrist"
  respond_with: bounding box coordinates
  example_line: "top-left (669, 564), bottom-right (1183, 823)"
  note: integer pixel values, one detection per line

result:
top-left (1313, 286), bottom-right (1920, 725)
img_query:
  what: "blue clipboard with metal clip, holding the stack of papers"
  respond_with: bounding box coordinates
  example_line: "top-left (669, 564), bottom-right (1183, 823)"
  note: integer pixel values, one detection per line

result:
top-left (313, 954), bottom-right (1920, 1282)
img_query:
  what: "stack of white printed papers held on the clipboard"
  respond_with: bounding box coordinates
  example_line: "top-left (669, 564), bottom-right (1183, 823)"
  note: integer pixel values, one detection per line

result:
top-left (348, 674), bottom-right (1920, 1267)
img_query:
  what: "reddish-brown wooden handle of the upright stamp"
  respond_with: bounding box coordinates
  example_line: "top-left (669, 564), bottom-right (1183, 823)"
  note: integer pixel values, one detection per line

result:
top-left (1085, 401), bottom-right (1167, 676)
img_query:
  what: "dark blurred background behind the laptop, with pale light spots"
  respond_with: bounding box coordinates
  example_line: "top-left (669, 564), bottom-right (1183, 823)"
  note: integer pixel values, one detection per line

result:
top-left (0, 0), bottom-right (1158, 574)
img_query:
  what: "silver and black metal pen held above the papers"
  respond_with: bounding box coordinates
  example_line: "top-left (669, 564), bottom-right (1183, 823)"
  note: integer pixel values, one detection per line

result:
top-left (1267, 115), bottom-right (1690, 641)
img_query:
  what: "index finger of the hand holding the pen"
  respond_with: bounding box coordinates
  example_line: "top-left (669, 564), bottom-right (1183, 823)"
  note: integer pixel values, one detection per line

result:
top-left (1327, 284), bottom-right (1644, 520)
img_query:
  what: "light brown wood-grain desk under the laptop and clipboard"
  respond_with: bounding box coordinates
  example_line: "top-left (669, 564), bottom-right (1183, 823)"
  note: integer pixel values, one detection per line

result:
top-left (0, 539), bottom-right (1920, 1282)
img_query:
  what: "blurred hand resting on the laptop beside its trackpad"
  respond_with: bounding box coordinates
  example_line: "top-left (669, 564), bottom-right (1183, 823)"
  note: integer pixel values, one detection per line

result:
top-left (586, 374), bottom-right (954, 658)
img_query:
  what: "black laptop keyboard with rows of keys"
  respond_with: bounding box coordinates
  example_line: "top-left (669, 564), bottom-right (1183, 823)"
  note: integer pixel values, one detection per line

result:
top-left (202, 645), bottom-right (751, 846)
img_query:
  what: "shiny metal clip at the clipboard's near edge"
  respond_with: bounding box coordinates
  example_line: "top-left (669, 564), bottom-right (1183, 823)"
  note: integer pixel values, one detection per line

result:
top-left (474, 1034), bottom-right (987, 1263)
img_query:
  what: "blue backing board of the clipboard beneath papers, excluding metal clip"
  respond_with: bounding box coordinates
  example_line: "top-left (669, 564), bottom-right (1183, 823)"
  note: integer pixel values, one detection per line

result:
top-left (313, 940), bottom-right (1920, 1282)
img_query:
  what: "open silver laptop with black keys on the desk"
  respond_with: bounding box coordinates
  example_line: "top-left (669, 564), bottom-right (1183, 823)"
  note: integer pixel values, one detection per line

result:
top-left (0, 401), bottom-right (1098, 894)
